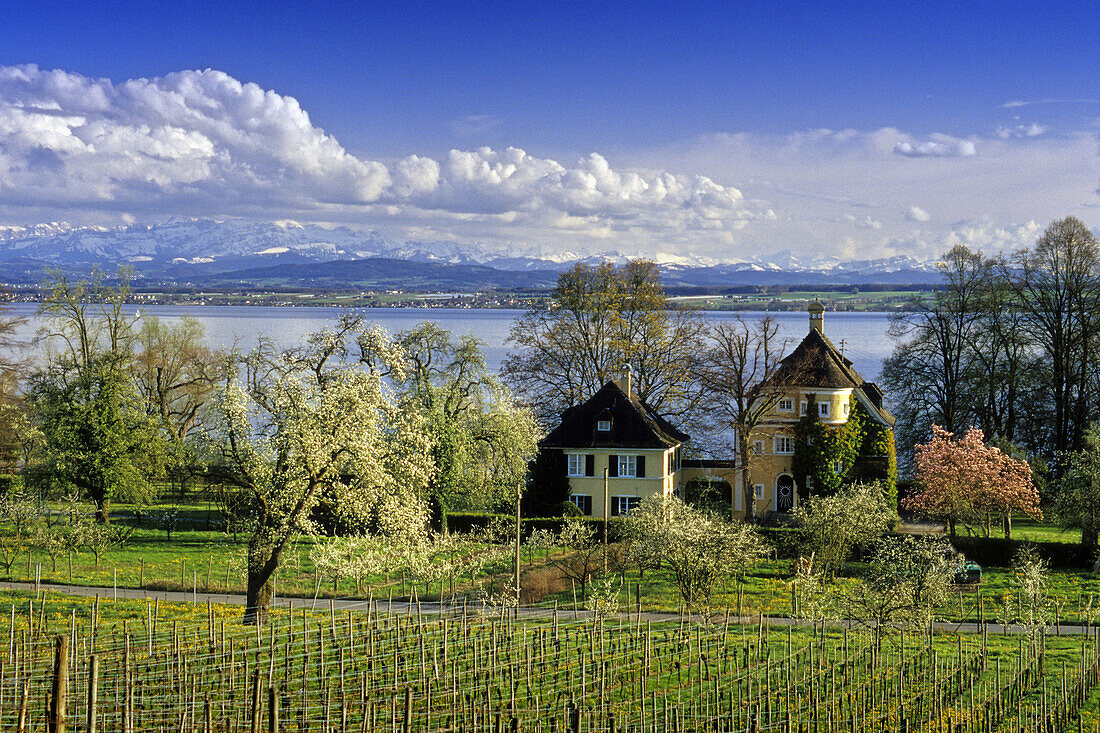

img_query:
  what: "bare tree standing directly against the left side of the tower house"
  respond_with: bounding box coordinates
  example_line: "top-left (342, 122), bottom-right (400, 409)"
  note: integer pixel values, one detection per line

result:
top-left (699, 316), bottom-right (804, 523)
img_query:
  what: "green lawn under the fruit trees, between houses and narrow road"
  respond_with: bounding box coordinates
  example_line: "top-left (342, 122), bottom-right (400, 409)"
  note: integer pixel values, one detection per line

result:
top-left (8, 505), bottom-right (1100, 624)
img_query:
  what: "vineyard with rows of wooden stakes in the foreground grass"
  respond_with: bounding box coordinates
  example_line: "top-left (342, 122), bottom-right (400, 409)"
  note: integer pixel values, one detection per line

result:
top-left (0, 597), bottom-right (1100, 733)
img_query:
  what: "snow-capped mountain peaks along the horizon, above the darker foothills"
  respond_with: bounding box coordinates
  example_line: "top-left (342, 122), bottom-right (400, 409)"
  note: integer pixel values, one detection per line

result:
top-left (0, 219), bottom-right (937, 286)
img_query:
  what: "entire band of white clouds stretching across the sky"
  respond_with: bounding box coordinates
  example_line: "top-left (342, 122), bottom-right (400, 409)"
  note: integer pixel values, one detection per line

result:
top-left (0, 65), bottom-right (1100, 260)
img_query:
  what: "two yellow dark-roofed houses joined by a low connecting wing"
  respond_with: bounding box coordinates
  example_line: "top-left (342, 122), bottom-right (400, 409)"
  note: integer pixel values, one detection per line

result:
top-left (539, 303), bottom-right (894, 517)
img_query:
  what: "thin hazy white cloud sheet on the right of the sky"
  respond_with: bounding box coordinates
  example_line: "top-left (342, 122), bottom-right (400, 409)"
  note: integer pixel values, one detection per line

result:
top-left (636, 128), bottom-right (1100, 259)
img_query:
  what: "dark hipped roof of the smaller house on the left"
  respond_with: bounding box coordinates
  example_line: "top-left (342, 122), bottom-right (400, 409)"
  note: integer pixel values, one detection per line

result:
top-left (539, 381), bottom-right (688, 449)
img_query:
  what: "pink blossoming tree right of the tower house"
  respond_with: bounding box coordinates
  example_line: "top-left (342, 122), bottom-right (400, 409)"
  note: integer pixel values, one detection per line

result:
top-left (903, 425), bottom-right (1043, 539)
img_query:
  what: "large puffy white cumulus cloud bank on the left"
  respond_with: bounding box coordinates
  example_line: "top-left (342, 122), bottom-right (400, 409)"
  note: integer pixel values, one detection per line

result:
top-left (0, 66), bottom-right (763, 256)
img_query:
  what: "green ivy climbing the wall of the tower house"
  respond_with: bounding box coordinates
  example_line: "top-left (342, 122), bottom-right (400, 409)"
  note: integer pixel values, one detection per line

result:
top-left (792, 395), bottom-right (898, 503)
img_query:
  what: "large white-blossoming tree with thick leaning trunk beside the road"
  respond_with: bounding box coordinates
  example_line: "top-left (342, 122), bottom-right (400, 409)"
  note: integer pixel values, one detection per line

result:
top-left (217, 315), bottom-right (432, 623)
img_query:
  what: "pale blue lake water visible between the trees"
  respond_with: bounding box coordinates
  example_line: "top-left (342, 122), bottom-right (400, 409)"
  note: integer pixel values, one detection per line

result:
top-left (4, 303), bottom-right (893, 381)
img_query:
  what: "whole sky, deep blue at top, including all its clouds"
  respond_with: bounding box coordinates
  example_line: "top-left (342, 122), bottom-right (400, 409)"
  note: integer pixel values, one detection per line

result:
top-left (0, 2), bottom-right (1100, 259)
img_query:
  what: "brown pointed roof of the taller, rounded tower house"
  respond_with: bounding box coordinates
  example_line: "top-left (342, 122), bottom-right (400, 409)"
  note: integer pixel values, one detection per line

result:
top-left (773, 328), bottom-right (894, 426)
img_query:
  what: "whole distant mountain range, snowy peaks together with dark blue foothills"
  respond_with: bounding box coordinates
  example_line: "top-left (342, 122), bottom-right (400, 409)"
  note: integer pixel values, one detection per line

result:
top-left (0, 219), bottom-right (939, 291)
